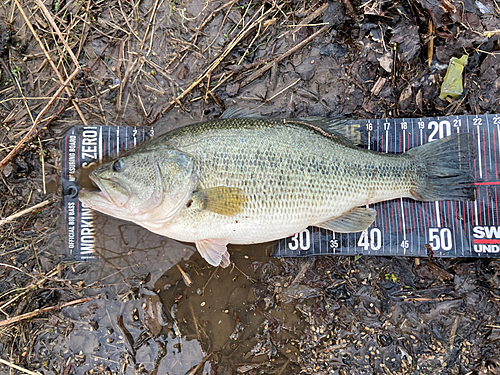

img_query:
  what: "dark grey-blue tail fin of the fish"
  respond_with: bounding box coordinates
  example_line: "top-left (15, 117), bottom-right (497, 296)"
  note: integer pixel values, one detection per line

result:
top-left (407, 133), bottom-right (476, 202)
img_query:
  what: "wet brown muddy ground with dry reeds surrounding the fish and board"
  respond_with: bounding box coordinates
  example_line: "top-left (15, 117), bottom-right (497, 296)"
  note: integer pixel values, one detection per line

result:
top-left (0, 0), bottom-right (500, 374)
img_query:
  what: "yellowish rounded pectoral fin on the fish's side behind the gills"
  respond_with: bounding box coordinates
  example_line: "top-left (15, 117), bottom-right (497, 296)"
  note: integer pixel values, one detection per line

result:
top-left (193, 186), bottom-right (247, 216)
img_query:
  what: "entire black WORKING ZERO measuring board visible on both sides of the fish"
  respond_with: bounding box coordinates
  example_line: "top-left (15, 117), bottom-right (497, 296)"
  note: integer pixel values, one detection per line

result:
top-left (62, 115), bottom-right (500, 260)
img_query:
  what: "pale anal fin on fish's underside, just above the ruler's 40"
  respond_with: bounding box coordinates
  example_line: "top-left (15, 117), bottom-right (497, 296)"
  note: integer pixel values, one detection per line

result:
top-left (315, 207), bottom-right (377, 233)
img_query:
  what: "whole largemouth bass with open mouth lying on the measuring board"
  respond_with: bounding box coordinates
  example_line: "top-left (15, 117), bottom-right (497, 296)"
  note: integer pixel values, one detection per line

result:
top-left (79, 116), bottom-right (476, 267)
